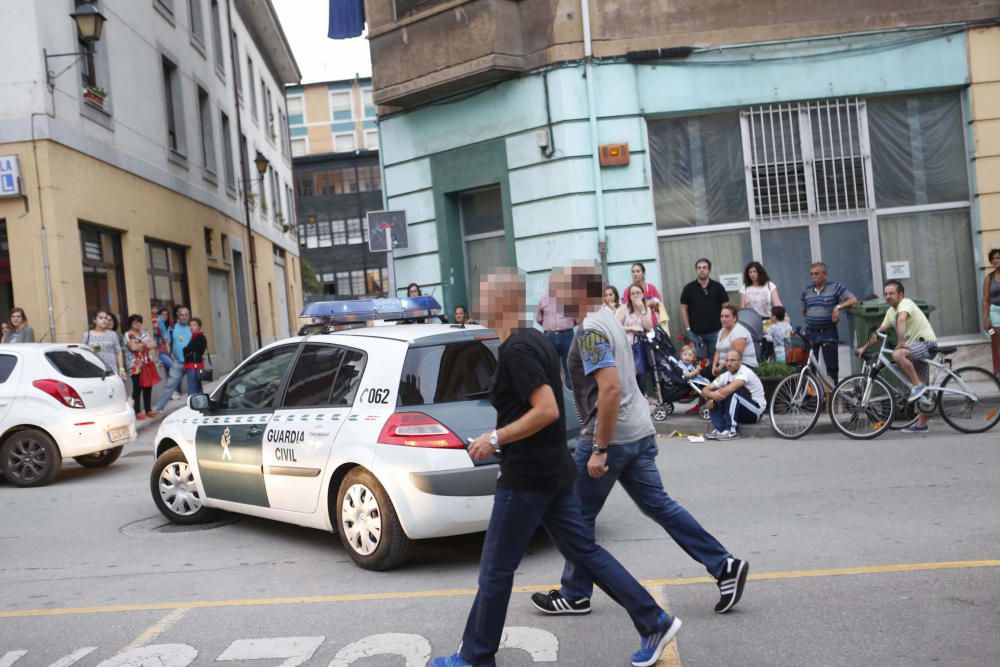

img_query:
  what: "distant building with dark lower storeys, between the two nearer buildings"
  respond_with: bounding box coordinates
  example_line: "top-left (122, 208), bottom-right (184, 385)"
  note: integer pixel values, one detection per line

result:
top-left (285, 78), bottom-right (389, 299)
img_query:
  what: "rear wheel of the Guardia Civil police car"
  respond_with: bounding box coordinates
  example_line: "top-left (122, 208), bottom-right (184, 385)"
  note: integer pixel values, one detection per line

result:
top-left (331, 468), bottom-right (413, 570)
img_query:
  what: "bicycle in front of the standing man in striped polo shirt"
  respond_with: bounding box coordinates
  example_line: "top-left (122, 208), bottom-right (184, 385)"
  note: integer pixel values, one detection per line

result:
top-left (770, 328), bottom-right (840, 440)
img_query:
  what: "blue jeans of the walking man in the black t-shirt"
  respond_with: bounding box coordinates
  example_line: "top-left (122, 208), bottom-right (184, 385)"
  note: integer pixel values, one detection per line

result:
top-left (461, 486), bottom-right (669, 665)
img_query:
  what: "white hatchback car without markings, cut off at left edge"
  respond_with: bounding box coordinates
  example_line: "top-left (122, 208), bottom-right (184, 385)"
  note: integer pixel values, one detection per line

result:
top-left (0, 343), bottom-right (135, 486)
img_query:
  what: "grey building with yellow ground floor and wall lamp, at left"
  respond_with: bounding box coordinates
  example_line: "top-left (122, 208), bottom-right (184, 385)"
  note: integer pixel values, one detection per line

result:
top-left (0, 0), bottom-right (302, 371)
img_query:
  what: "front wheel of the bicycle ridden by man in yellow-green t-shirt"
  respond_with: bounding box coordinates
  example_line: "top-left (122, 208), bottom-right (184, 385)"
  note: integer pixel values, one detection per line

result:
top-left (830, 375), bottom-right (896, 440)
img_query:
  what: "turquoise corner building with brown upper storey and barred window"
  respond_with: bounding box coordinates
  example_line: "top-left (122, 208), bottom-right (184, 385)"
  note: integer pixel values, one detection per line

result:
top-left (366, 0), bottom-right (1000, 354)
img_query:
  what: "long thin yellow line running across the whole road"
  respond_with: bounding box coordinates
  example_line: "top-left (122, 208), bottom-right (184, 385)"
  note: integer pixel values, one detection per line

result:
top-left (0, 560), bottom-right (1000, 618)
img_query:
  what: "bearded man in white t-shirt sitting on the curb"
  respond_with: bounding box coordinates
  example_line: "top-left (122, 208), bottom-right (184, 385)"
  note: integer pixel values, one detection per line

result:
top-left (701, 350), bottom-right (767, 440)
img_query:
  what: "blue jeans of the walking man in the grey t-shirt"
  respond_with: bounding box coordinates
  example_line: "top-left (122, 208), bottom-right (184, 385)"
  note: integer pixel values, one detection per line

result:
top-left (562, 435), bottom-right (732, 600)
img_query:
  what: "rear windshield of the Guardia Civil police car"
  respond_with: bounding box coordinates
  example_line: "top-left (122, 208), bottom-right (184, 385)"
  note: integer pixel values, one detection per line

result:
top-left (399, 339), bottom-right (499, 406)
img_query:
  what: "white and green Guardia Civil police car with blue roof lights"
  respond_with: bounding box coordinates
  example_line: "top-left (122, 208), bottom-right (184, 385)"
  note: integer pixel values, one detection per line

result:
top-left (150, 297), bottom-right (579, 570)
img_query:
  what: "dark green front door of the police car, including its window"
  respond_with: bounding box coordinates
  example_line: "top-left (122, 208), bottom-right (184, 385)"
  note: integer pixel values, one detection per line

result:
top-left (195, 343), bottom-right (299, 507)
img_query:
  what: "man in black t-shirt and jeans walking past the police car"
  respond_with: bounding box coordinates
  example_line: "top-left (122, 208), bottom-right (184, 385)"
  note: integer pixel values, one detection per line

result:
top-left (431, 269), bottom-right (681, 667)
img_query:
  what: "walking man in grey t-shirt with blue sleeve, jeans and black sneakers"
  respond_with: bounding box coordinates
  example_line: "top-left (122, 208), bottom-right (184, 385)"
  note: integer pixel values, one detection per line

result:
top-left (531, 263), bottom-right (750, 614)
